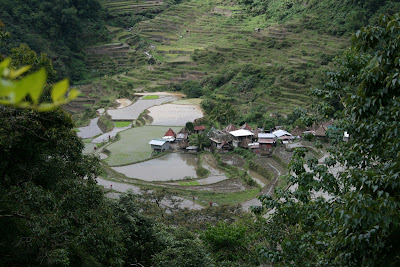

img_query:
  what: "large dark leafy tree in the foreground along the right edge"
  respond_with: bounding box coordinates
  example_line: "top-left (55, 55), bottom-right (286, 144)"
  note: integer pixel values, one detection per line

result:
top-left (260, 14), bottom-right (400, 266)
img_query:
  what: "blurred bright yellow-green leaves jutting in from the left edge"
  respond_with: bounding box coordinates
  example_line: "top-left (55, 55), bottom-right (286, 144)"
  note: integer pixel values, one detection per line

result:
top-left (0, 58), bottom-right (79, 111)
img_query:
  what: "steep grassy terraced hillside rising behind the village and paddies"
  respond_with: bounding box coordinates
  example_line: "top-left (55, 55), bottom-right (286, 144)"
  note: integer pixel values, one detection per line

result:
top-left (71, 0), bottom-right (398, 124)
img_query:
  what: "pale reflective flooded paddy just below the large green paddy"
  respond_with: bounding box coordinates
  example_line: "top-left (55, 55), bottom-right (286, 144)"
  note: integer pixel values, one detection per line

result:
top-left (113, 153), bottom-right (198, 181)
